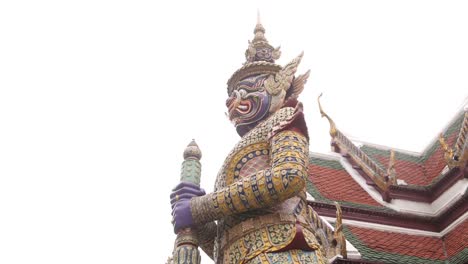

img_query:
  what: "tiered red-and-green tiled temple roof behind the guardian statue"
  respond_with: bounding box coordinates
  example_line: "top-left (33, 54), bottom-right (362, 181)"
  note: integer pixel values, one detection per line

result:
top-left (307, 99), bottom-right (468, 263)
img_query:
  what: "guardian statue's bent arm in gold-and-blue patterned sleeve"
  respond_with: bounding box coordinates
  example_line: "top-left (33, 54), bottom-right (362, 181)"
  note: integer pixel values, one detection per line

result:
top-left (190, 128), bottom-right (308, 225)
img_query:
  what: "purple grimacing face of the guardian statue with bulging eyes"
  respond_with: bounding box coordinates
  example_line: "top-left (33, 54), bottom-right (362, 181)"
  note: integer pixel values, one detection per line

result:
top-left (226, 74), bottom-right (271, 136)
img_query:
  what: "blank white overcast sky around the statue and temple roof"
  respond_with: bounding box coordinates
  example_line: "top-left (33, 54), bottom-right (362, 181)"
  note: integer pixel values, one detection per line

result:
top-left (0, 0), bottom-right (468, 264)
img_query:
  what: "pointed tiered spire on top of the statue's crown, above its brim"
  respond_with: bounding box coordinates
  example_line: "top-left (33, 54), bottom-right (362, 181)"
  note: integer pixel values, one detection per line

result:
top-left (245, 9), bottom-right (281, 64)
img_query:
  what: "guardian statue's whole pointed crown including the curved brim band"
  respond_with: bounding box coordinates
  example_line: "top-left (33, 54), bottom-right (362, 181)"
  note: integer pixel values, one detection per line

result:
top-left (227, 14), bottom-right (281, 95)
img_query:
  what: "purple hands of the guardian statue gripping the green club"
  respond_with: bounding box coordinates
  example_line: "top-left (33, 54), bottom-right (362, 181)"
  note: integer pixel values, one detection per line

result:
top-left (170, 182), bottom-right (205, 233)
